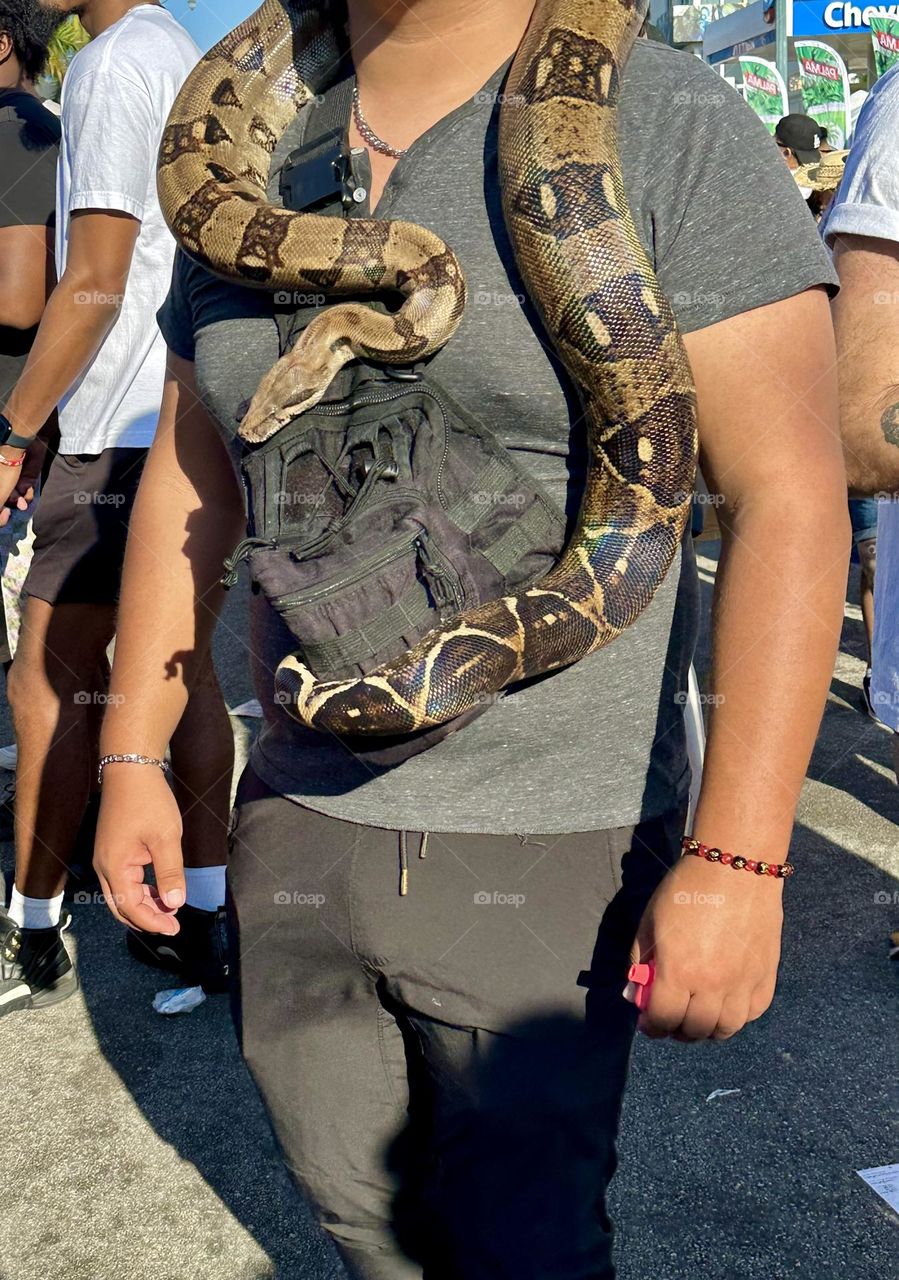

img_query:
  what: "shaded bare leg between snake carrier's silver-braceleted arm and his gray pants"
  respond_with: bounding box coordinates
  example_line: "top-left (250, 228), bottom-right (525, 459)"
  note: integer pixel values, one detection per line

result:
top-left (172, 655), bottom-right (234, 870)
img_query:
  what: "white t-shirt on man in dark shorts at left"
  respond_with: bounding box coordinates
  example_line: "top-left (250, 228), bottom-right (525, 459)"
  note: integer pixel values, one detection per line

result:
top-left (56, 4), bottom-right (200, 453)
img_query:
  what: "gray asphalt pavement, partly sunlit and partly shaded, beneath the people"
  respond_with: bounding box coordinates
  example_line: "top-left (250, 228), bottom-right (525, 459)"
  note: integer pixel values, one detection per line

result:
top-left (0, 543), bottom-right (899, 1280)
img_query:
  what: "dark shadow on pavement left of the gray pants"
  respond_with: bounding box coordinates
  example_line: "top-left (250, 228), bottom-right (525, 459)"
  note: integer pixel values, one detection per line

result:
top-left (73, 905), bottom-right (343, 1280)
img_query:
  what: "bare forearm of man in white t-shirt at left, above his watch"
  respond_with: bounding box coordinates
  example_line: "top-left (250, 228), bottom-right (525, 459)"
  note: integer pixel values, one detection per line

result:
top-left (0, 273), bottom-right (122, 435)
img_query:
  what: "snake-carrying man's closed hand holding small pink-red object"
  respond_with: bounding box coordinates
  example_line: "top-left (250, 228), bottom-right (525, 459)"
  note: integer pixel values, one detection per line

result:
top-left (633, 858), bottom-right (784, 1041)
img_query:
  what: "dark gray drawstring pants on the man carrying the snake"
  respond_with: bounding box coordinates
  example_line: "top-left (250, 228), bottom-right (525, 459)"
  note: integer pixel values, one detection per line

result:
top-left (229, 771), bottom-right (684, 1280)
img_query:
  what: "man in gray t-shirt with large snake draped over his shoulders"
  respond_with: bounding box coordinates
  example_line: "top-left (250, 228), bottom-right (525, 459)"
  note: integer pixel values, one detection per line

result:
top-left (96, 0), bottom-right (848, 1280)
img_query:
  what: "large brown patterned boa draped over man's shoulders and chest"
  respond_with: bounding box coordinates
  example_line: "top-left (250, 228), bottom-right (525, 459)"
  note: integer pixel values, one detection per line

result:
top-left (159, 0), bottom-right (697, 735)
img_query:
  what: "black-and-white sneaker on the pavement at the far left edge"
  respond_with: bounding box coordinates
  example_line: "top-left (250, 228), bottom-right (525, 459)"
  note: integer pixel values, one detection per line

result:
top-left (0, 910), bottom-right (78, 1018)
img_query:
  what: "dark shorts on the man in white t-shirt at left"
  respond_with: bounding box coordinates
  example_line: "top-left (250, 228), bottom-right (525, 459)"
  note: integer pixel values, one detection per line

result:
top-left (23, 449), bottom-right (147, 604)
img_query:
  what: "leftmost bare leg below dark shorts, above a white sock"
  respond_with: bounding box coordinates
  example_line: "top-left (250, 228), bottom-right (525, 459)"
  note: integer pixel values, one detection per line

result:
top-left (6, 596), bottom-right (115, 899)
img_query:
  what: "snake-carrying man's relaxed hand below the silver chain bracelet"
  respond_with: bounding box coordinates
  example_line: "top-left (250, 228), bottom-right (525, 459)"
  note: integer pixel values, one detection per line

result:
top-left (93, 764), bottom-right (184, 934)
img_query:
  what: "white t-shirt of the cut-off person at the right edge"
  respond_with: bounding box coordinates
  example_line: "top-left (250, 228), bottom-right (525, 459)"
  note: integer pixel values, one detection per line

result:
top-left (823, 67), bottom-right (899, 731)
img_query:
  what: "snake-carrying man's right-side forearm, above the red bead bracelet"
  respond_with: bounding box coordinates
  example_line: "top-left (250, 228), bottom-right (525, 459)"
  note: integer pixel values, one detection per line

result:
top-left (694, 494), bottom-right (850, 861)
